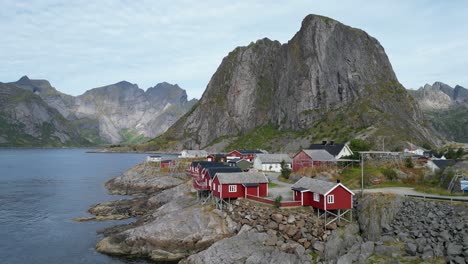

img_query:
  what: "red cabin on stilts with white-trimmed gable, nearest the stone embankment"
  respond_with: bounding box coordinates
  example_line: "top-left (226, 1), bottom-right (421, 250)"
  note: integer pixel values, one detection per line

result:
top-left (291, 177), bottom-right (354, 210)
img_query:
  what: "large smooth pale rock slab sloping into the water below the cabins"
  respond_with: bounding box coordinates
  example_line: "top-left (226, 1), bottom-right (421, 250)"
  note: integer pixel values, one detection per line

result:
top-left (96, 186), bottom-right (232, 261)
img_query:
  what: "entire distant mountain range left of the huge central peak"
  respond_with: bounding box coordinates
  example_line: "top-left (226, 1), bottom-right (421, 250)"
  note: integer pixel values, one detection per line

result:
top-left (0, 76), bottom-right (197, 147)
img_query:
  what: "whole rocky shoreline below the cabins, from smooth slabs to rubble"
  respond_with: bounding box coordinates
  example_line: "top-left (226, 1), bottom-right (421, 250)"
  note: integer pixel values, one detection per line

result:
top-left (85, 164), bottom-right (468, 264)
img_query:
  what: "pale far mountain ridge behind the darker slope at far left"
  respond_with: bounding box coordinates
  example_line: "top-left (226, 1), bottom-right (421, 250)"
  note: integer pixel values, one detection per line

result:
top-left (3, 76), bottom-right (196, 145)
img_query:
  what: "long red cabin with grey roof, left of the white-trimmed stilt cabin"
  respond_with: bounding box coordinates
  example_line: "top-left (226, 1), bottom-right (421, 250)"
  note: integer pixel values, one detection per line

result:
top-left (211, 172), bottom-right (268, 199)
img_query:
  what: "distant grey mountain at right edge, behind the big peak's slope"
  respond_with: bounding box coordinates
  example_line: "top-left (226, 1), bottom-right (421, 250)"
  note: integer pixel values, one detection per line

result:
top-left (408, 82), bottom-right (468, 143)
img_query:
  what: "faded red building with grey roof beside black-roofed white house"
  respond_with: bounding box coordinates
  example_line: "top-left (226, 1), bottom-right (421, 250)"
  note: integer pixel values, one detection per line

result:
top-left (292, 149), bottom-right (336, 171)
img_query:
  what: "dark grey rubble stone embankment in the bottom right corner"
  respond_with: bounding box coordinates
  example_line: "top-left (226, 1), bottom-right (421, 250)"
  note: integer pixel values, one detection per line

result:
top-left (383, 200), bottom-right (468, 263)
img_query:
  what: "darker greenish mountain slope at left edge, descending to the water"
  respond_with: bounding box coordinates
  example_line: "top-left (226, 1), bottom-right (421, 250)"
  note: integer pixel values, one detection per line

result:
top-left (0, 83), bottom-right (91, 147)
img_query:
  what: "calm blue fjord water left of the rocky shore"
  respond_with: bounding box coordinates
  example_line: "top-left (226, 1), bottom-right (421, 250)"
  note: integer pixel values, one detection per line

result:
top-left (0, 149), bottom-right (169, 263)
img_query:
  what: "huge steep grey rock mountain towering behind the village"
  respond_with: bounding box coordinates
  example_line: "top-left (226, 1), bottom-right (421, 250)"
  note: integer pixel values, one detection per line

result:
top-left (145, 15), bottom-right (437, 151)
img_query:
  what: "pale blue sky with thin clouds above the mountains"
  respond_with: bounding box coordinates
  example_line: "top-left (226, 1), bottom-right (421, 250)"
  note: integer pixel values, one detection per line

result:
top-left (0, 0), bottom-right (468, 98)
